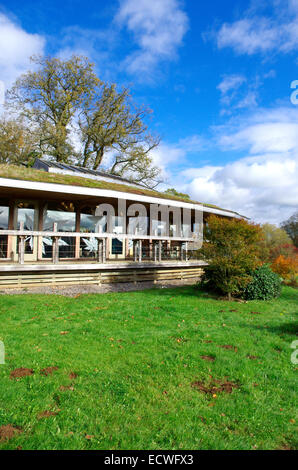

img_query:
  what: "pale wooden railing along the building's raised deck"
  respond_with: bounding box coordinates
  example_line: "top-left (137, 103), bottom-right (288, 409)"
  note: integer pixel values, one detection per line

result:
top-left (0, 223), bottom-right (203, 264)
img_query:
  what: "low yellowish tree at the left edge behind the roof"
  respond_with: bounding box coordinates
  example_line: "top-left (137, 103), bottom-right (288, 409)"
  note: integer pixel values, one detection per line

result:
top-left (0, 118), bottom-right (39, 165)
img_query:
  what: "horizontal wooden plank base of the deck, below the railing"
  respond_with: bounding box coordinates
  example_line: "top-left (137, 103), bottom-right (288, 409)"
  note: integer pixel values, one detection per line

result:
top-left (0, 261), bottom-right (205, 289)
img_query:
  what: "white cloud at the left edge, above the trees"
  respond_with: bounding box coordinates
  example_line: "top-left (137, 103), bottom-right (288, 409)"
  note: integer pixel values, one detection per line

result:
top-left (0, 13), bottom-right (45, 87)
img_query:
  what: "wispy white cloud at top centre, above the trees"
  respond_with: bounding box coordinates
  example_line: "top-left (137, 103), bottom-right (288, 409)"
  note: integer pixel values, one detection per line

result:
top-left (116, 0), bottom-right (188, 74)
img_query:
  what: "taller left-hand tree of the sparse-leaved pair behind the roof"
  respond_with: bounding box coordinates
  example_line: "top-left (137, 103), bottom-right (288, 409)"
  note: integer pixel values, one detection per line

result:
top-left (7, 56), bottom-right (100, 162)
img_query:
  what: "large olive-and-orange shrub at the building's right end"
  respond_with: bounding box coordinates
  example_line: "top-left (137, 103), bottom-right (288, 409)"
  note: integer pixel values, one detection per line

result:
top-left (201, 215), bottom-right (263, 299)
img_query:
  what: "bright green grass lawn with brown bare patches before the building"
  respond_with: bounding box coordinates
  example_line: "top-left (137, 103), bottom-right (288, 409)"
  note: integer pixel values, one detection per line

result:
top-left (0, 287), bottom-right (298, 449)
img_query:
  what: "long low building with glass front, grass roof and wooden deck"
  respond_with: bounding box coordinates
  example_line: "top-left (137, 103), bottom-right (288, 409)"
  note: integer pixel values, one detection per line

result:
top-left (0, 159), bottom-right (246, 288)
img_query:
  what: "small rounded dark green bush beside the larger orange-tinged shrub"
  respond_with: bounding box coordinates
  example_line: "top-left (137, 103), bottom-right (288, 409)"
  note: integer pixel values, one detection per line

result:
top-left (244, 264), bottom-right (281, 300)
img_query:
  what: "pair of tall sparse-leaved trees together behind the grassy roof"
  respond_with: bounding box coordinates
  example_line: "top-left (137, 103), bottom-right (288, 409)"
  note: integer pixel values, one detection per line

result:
top-left (7, 56), bottom-right (161, 188)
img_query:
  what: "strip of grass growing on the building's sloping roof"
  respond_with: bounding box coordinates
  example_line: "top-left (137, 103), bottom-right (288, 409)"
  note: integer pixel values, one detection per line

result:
top-left (0, 164), bottom-right (237, 213)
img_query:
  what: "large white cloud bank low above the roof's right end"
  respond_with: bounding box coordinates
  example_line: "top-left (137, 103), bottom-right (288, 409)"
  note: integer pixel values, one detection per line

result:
top-left (163, 108), bottom-right (298, 223)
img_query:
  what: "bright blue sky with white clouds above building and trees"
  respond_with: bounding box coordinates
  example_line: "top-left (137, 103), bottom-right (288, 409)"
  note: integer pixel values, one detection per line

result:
top-left (0, 0), bottom-right (298, 223)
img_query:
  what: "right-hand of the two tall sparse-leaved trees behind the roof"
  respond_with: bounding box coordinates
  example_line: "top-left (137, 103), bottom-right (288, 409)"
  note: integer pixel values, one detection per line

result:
top-left (79, 83), bottom-right (160, 187)
